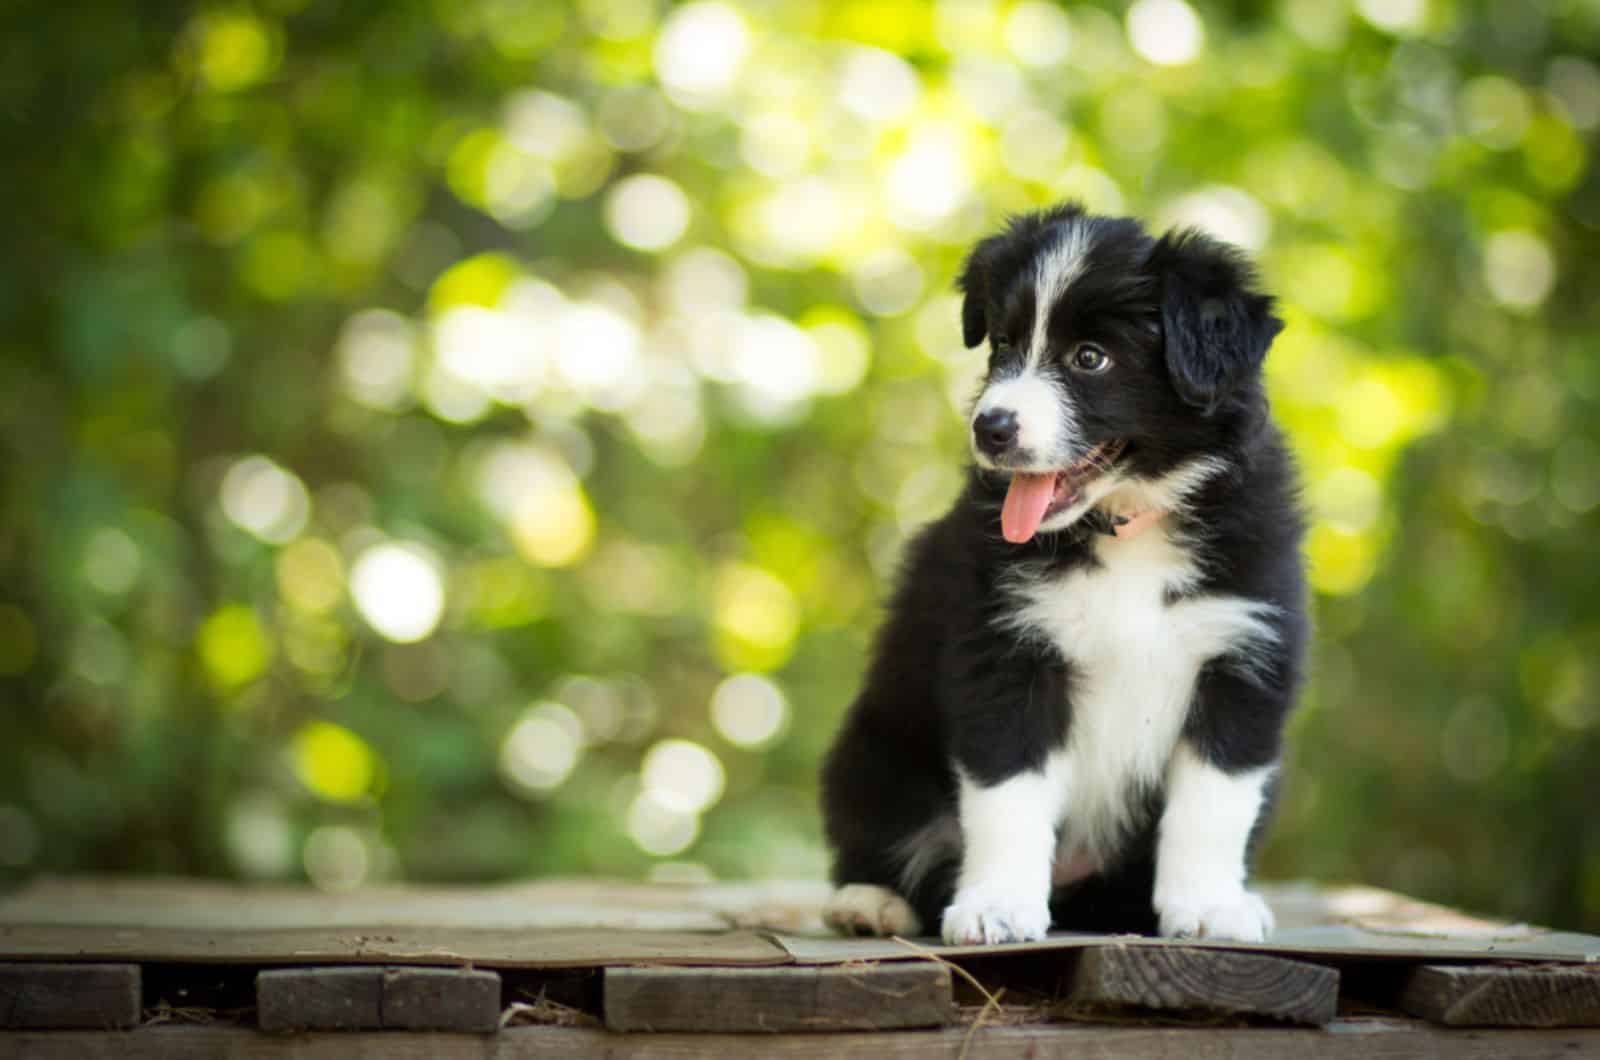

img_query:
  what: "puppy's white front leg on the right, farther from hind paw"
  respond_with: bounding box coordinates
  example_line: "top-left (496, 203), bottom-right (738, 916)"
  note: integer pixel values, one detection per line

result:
top-left (1155, 741), bottom-right (1272, 942)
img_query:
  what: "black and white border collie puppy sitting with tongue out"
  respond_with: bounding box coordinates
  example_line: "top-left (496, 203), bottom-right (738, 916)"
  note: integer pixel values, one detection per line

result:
top-left (822, 205), bottom-right (1309, 943)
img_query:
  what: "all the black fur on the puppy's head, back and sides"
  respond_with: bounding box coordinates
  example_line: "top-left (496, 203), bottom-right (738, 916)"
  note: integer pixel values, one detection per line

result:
top-left (822, 205), bottom-right (1307, 932)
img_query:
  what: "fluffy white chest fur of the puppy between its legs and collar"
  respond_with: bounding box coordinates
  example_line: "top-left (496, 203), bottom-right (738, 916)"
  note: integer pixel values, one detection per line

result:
top-left (1011, 525), bottom-right (1274, 873)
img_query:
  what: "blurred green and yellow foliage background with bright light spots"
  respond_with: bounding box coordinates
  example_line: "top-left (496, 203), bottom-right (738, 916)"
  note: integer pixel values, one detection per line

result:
top-left (0, 0), bottom-right (1600, 929)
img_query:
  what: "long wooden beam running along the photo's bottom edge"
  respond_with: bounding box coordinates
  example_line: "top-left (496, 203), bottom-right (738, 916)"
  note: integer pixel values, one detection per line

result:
top-left (9, 1018), bottom-right (1600, 1060)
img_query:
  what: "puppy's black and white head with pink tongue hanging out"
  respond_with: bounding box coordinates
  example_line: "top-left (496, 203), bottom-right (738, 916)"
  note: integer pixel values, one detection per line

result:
top-left (960, 205), bottom-right (1283, 541)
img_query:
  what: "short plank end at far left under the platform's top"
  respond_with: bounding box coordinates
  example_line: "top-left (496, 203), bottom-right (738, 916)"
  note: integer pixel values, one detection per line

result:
top-left (0, 962), bottom-right (141, 1028)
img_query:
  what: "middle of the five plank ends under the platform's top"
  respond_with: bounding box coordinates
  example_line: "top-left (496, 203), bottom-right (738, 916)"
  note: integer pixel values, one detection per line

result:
top-left (605, 962), bottom-right (954, 1031)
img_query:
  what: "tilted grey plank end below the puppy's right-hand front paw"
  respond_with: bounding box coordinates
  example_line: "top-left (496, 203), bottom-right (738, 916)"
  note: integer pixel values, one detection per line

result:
top-left (1067, 945), bottom-right (1339, 1025)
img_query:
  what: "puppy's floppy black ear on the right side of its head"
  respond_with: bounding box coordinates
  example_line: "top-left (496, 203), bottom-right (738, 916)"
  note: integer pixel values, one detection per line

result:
top-left (1150, 232), bottom-right (1283, 416)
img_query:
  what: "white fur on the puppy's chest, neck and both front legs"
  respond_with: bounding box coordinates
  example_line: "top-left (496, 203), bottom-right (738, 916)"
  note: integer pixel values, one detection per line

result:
top-left (944, 463), bottom-right (1275, 942)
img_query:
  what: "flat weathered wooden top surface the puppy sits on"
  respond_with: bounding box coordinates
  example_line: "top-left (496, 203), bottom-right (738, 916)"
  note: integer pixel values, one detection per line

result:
top-left (0, 877), bottom-right (1600, 969)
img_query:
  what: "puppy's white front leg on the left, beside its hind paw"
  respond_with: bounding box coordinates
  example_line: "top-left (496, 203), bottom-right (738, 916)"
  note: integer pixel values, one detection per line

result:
top-left (942, 770), bottom-right (1061, 945)
